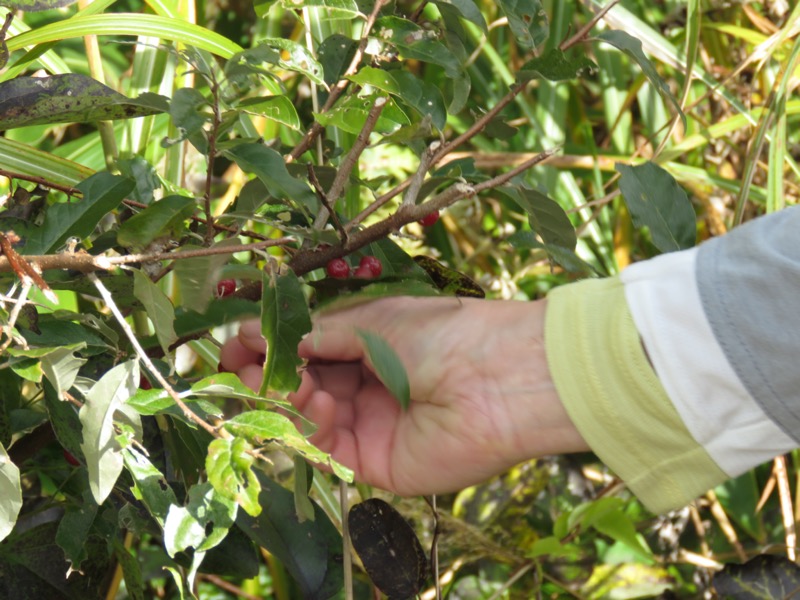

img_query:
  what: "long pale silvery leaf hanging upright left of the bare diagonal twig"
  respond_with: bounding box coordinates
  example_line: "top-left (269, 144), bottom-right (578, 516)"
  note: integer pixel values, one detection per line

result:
top-left (79, 361), bottom-right (139, 504)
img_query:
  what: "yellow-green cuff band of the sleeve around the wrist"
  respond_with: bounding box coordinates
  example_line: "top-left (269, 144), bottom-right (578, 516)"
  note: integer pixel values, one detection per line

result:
top-left (545, 277), bottom-right (728, 513)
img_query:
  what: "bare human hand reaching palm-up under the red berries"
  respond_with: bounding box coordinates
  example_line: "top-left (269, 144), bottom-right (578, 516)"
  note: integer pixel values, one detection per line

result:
top-left (222, 297), bottom-right (588, 495)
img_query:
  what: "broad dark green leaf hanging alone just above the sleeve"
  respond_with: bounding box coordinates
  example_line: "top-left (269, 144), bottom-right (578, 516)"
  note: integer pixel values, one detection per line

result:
top-left (615, 162), bottom-right (697, 252)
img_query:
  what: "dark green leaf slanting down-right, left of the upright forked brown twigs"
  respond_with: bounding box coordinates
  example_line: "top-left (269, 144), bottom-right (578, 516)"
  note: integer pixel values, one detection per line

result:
top-left (223, 144), bottom-right (318, 213)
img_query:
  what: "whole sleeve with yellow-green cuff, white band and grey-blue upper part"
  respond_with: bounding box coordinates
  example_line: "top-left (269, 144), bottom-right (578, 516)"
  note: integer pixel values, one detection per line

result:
top-left (545, 207), bottom-right (800, 512)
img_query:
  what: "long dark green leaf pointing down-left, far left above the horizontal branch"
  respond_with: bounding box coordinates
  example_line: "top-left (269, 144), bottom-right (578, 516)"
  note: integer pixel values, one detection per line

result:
top-left (25, 171), bottom-right (134, 254)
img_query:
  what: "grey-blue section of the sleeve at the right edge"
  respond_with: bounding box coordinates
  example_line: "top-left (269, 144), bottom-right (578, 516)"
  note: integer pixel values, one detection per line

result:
top-left (696, 206), bottom-right (800, 444)
